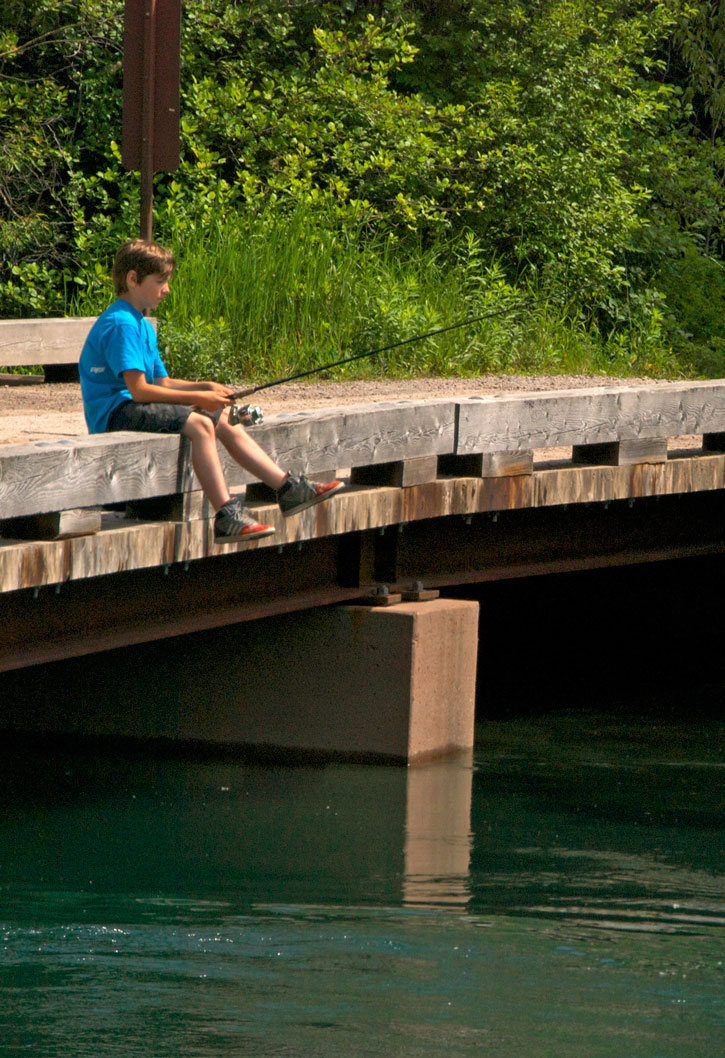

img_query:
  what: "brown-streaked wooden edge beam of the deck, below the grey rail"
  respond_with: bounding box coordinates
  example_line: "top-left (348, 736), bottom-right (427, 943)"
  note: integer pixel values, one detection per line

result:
top-left (0, 453), bottom-right (725, 594)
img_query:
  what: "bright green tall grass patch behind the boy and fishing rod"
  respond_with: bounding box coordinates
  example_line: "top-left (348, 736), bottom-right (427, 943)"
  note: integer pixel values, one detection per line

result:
top-left (70, 206), bottom-right (677, 382)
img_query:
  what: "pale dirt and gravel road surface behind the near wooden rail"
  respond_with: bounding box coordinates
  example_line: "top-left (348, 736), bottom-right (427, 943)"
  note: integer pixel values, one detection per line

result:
top-left (0, 375), bottom-right (651, 444)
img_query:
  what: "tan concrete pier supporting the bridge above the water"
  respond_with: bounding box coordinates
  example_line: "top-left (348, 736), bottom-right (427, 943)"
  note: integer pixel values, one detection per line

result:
top-left (175, 599), bottom-right (478, 763)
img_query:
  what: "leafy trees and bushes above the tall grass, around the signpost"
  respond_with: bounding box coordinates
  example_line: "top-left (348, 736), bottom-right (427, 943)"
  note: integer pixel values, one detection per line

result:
top-left (0, 0), bottom-right (725, 378)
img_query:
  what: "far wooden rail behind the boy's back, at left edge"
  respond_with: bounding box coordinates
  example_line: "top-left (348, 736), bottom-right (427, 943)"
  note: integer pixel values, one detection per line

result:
top-left (0, 316), bottom-right (157, 367)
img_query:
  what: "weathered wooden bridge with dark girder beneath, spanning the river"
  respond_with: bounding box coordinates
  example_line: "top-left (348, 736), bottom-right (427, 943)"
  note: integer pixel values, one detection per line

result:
top-left (0, 381), bottom-right (725, 755)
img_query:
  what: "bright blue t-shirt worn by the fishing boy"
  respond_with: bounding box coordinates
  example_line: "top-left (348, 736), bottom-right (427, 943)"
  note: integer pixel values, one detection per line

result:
top-left (78, 297), bottom-right (168, 434)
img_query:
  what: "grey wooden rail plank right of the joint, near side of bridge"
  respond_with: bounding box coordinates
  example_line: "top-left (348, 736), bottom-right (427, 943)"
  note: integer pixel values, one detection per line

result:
top-left (456, 381), bottom-right (725, 455)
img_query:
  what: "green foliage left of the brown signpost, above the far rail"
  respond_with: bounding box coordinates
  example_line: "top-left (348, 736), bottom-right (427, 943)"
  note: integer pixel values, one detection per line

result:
top-left (0, 0), bottom-right (126, 315)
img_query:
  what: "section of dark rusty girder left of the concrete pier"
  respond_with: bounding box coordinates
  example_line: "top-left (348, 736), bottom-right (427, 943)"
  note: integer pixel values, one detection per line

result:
top-left (0, 526), bottom-right (368, 672)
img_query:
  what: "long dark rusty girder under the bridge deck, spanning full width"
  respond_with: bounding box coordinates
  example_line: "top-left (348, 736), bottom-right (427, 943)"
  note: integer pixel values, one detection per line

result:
top-left (5, 484), bottom-right (725, 671)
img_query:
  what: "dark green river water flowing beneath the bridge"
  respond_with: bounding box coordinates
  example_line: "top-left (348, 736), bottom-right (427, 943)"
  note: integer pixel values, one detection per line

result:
top-left (0, 715), bottom-right (725, 1058)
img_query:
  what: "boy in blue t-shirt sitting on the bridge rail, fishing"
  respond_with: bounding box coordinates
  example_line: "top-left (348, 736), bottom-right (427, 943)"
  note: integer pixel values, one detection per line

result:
top-left (78, 239), bottom-right (344, 543)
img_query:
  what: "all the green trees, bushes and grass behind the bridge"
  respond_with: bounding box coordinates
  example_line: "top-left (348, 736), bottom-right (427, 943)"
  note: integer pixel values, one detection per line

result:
top-left (0, 0), bottom-right (725, 373)
